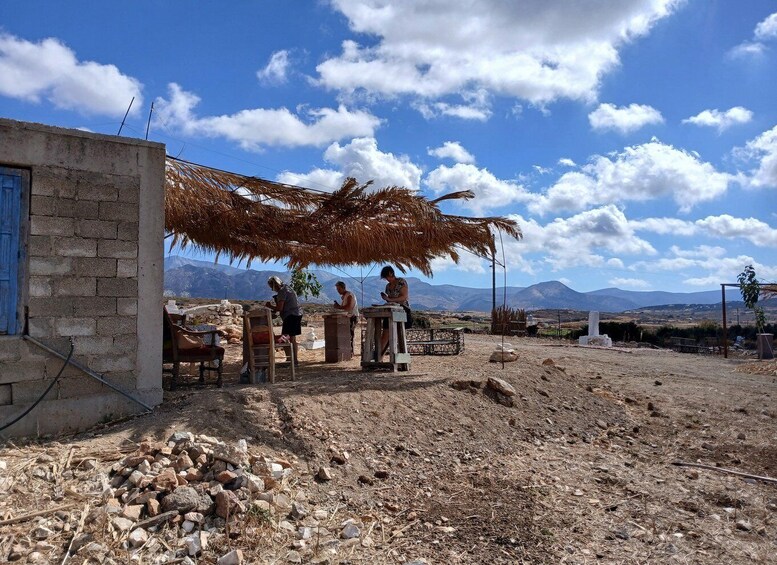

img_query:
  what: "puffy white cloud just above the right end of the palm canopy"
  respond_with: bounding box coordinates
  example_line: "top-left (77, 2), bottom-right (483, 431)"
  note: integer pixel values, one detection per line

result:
top-left (425, 163), bottom-right (528, 214)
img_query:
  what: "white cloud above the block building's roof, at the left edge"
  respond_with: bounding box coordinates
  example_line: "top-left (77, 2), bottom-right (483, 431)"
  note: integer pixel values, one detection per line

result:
top-left (0, 33), bottom-right (143, 117)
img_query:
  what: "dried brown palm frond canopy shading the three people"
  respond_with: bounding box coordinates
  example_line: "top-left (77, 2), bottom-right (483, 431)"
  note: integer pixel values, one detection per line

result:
top-left (165, 157), bottom-right (521, 275)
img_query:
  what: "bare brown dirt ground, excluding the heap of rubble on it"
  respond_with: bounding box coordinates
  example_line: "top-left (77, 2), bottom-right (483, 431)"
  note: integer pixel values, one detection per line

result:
top-left (0, 335), bottom-right (777, 564)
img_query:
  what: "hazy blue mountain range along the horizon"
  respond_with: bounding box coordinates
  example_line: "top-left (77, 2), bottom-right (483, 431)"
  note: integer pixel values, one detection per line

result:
top-left (164, 256), bottom-right (739, 312)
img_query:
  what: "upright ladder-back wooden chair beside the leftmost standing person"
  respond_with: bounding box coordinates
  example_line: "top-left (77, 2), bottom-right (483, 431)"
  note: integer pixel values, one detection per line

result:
top-left (243, 307), bottom-right (296, 384)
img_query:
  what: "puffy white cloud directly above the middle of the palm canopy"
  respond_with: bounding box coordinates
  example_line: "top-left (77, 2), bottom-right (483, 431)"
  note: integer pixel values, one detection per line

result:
top-left (278, 137), bottom-right (421, 190)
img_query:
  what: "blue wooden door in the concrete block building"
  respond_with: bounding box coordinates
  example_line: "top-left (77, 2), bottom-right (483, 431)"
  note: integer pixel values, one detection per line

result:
top-left (0, 167), bottom-right (22, 335)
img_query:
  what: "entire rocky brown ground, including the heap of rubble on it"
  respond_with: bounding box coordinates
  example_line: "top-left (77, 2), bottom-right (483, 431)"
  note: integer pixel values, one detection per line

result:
top-left (0, 335), bottom-right (777, 564)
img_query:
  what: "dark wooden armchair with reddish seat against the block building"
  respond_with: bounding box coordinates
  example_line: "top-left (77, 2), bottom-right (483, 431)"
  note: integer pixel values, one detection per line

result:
top-left (162, 308), bottom-right (224, 390)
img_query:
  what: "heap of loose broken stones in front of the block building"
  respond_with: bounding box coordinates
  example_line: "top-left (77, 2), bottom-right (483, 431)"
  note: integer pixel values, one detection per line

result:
top-left (88, 432), bottom-right (371, 563)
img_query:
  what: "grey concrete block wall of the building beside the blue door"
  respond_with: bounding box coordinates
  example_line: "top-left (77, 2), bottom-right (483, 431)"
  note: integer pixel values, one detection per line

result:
top-left (0, 119), bottom-right (165, 436)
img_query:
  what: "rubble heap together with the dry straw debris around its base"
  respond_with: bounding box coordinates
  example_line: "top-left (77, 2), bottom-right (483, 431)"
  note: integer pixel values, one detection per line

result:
top-left (0, 432), bottom-right (373, 565)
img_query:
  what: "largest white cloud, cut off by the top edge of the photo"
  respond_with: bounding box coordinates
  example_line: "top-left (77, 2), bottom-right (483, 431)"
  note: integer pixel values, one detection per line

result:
top-left (317, 0), bottom-right (679, 104)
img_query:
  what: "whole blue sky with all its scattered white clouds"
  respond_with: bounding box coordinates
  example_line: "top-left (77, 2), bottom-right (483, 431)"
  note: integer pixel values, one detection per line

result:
top-left (0, 0), bottom-right (777, 292)
